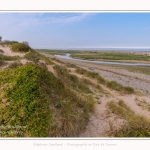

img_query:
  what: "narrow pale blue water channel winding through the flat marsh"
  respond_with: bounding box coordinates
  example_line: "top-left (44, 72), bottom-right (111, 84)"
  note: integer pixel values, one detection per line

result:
top-left (55, 53), bottom-right (150, 66)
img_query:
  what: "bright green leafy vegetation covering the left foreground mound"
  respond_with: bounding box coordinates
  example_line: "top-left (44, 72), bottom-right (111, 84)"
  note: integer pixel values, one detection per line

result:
top-left (0, 64), bottom-right (52, 137)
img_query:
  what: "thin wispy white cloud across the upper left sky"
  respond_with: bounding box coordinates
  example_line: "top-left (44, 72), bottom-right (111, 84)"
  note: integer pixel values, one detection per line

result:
top-left (0, 13), bottom-right (92, 30)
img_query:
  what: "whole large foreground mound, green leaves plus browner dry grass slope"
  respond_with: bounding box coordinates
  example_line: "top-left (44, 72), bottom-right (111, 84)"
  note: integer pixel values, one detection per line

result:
top-left (0, 63), bottom-right (93, 137)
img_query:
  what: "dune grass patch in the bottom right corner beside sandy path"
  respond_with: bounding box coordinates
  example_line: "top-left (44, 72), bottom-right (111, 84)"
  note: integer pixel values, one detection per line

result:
top-left (107, 100), bottom-right (150, 137)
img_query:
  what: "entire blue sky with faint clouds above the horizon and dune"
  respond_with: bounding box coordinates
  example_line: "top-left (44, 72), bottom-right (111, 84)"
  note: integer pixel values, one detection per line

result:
top-left (0, 12), bottom-right (150, 49)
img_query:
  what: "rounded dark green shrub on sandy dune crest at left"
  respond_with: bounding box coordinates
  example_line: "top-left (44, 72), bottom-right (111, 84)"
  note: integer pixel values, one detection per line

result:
top-left (11, 43), bottom-right (30, 52)
